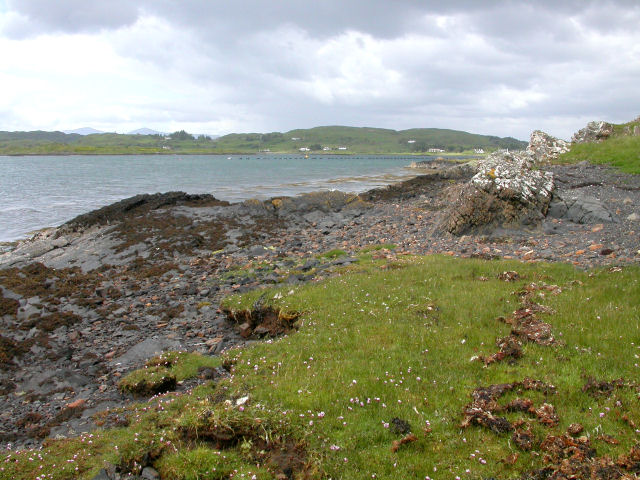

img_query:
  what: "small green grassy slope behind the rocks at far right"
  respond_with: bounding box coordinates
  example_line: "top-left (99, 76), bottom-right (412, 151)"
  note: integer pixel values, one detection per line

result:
top-left (558, 136), bottom-right (640, 174)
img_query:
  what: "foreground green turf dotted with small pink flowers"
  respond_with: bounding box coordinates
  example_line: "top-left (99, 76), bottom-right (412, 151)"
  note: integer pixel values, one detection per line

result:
top-left (0, 256), bottom-right (640, 479)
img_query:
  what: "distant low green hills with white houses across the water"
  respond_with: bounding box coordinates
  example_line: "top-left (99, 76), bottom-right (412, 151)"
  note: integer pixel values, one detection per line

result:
top-left (0, 126), bottom-right (526, 155)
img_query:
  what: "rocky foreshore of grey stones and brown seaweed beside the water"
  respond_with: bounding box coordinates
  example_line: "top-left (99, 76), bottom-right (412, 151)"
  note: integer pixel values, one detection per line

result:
top-left (0, 124), bottom-right (640, 448)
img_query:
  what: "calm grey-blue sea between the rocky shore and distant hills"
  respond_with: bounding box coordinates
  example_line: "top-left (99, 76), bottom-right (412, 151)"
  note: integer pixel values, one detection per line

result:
top-left (0, 155), bottom-right (430, 242)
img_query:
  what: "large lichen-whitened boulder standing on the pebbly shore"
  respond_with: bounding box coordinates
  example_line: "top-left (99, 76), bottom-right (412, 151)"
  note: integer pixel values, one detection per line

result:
top-left (439, 151), bottom-right (555, 235)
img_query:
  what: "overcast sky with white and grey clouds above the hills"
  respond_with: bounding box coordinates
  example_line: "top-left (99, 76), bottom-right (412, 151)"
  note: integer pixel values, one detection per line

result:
top-left (0, 0), bottom-right (640, 139)
